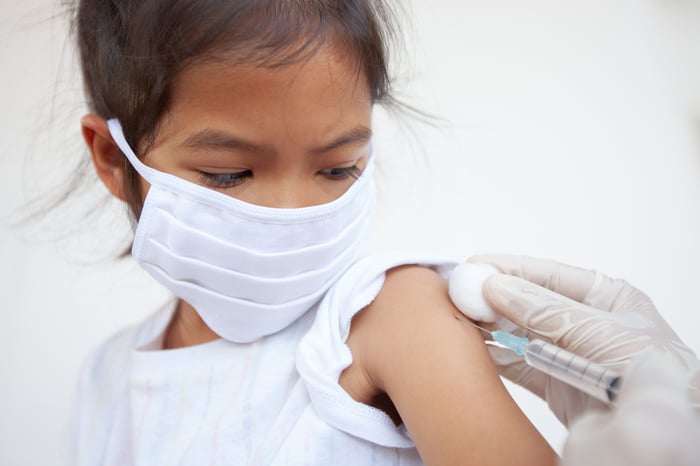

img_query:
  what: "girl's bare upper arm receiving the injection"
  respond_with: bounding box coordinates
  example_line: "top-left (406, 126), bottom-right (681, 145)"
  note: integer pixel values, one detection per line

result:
top-left (341, 266), bottom-right (556, 466)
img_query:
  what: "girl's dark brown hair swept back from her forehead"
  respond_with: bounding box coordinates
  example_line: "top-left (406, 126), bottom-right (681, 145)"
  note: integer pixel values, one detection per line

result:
top-left (74, 0), bottom-right (397, 218)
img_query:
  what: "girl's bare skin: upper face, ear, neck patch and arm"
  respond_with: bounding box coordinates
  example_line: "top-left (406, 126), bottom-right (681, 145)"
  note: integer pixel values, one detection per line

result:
top-left (82, 44), bottom-right (556, 466)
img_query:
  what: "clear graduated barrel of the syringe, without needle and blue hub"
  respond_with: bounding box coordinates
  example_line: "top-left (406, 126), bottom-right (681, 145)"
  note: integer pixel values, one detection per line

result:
top-left (524, 339), bottom-right (620, 403)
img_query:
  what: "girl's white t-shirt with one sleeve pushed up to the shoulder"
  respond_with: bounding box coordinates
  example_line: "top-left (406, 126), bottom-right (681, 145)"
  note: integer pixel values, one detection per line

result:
top-left (72, 253), bottom-right (456, 466)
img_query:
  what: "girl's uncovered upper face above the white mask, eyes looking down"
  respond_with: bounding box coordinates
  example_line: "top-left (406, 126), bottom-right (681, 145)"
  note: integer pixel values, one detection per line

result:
top-left (143, 47), bottom-right (372, 207)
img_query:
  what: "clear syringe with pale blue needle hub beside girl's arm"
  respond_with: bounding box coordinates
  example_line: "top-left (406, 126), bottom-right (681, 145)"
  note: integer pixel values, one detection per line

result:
top-left (457, 317), bottom-right (622, 403)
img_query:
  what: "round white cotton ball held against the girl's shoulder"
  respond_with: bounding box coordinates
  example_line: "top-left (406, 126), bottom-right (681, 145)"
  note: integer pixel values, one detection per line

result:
top-left (449, 262), bottom-right (500, 322)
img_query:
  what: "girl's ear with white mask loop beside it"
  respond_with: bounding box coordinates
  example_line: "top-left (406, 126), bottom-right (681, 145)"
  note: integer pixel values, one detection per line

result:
top-left (80, 114), bottom-right (126, 201)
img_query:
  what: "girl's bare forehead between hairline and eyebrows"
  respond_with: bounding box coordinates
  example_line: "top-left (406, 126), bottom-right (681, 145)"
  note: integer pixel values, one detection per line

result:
top-left (160, 47), bottom-right (372, 144)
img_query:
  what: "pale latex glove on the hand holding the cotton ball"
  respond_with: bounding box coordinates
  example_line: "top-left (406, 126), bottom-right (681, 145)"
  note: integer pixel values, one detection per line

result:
top-left (469, 255), bottom-right (700, 426)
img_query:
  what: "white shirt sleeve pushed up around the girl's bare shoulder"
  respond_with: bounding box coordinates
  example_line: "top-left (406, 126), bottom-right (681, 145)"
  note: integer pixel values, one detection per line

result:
top-left (296, 252), bottom-right (459, 448)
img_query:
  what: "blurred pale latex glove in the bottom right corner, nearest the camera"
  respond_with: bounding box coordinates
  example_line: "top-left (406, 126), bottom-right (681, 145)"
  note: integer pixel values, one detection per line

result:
top-left (560, 353), bottom-right (700, 466)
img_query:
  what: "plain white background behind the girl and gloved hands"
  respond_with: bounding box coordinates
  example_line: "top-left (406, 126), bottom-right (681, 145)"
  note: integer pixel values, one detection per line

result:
top-left (0, 0), bottom-right (700, 465)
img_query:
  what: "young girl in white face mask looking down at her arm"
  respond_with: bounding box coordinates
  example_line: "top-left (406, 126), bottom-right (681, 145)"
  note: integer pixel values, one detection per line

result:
top-left (74, 0), bottom-right (555, 466)
